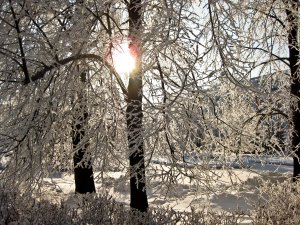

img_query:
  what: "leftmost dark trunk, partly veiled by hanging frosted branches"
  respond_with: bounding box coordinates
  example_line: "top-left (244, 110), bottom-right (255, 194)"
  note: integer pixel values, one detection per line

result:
top-left (72, 73), bottom-right (96, 194)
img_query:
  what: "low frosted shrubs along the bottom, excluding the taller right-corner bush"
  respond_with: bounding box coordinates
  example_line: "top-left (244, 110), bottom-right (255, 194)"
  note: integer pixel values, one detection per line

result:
top-left (0, 191), bottom-right (238, 225)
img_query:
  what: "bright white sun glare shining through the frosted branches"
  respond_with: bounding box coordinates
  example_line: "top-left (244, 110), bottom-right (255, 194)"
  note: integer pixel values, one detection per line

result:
top-left (111, 41), bottom-right (135, 76)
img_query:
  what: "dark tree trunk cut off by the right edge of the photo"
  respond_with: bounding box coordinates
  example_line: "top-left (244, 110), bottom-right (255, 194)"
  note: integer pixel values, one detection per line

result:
top-left (286, 0), bottom-right (300, 181)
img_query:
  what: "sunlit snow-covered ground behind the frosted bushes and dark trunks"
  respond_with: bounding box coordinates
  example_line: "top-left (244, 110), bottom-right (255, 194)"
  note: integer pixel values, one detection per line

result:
top-left (40, 156), bottom-right (293, 224)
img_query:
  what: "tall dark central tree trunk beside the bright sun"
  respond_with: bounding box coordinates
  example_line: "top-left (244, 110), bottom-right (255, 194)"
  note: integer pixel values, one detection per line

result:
top-left (126, 0), bottom-right (148, 212)
